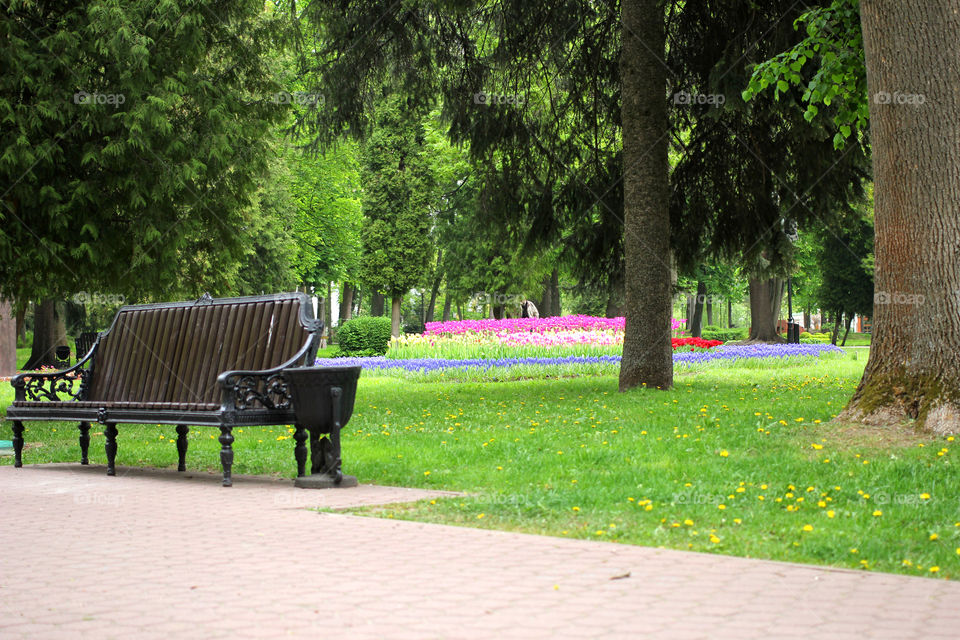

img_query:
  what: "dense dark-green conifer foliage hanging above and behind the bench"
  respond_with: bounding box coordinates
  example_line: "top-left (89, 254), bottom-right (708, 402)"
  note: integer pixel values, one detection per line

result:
top-left (0, 0), bottom-right (288, 300)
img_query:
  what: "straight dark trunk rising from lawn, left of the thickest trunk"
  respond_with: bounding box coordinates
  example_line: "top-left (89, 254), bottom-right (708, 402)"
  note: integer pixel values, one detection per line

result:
top-left (620, 0), bottom-right (673, 391)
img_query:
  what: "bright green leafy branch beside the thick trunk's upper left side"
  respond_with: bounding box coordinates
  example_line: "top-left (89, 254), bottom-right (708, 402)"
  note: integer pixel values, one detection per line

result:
top-left (743, 0), bottom-right (869, 149)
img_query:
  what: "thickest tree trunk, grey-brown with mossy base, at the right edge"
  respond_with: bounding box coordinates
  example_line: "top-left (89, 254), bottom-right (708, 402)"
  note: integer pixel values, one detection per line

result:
top-left (840, 0), bottom-right (960, 433)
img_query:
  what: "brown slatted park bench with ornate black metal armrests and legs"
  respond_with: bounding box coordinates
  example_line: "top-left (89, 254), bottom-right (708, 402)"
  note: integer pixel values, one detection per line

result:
top-left (6, 293), bottom-right (356, 487)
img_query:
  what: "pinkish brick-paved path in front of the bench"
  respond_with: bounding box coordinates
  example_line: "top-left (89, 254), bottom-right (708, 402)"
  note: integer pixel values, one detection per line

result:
top-left (0, 465), bottom-right (960, 640)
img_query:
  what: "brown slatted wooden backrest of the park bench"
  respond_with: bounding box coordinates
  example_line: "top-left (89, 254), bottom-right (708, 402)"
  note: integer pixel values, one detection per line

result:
top-left (86, 293), bottom-right (322, 403)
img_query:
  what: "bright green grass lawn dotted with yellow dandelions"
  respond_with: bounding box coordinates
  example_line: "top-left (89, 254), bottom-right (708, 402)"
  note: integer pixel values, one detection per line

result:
top-left (0, 350), bottom-right (960, 579)
